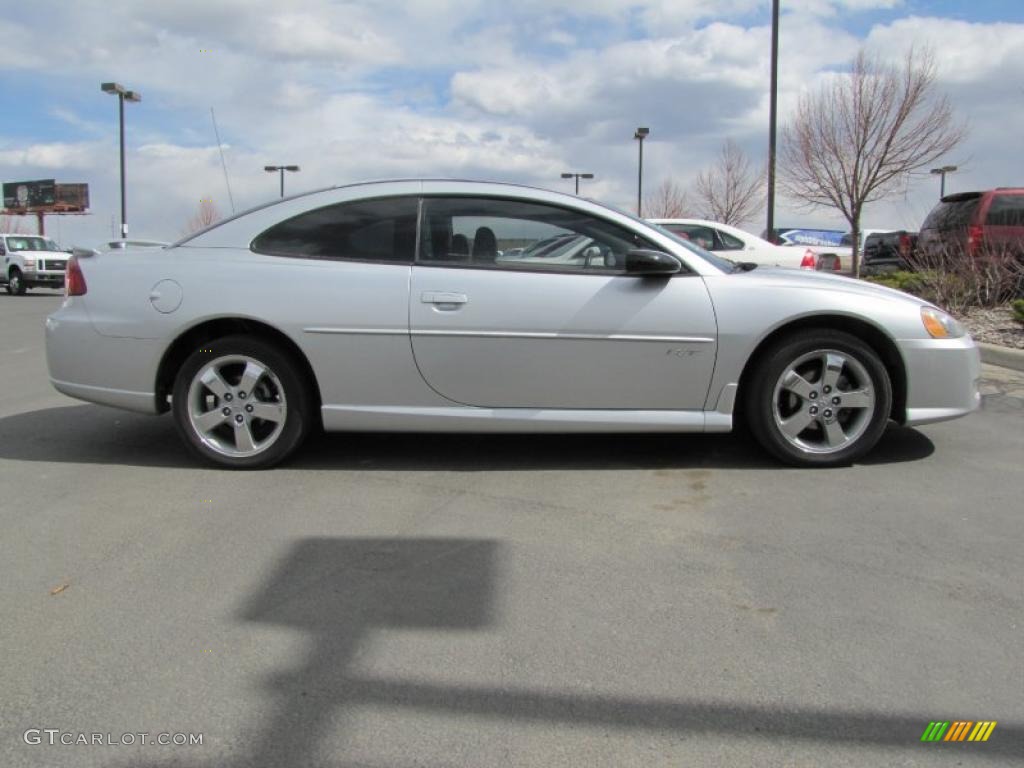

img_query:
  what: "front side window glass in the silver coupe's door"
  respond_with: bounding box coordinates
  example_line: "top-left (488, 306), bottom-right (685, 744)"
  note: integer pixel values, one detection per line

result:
top-left (419, 198), bottom-right (657, 273)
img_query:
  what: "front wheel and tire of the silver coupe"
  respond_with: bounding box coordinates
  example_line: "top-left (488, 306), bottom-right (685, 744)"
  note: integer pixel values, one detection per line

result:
top-left (743, 330), bottom-right (892, 467)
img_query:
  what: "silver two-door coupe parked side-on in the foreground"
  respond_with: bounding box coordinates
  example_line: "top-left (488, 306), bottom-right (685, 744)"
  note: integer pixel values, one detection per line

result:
top-left (46, 180), bottom-right (980, 467)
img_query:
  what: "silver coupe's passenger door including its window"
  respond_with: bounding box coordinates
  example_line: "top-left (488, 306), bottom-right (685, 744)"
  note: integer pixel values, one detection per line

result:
top-left (410, 198), bottom-right (717, 410)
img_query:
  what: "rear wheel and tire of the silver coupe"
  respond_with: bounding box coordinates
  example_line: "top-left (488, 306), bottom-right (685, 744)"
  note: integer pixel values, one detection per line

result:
top-left (171, 335), bottom-right (313, 469)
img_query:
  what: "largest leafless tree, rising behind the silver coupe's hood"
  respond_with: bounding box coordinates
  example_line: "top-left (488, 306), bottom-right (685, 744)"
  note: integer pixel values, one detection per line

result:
top-left (780, 48), bottom-right (967, 275)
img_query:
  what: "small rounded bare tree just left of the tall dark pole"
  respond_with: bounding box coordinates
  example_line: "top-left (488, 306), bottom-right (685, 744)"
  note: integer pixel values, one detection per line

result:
top-left (693, 138), bottom-right (765, 226)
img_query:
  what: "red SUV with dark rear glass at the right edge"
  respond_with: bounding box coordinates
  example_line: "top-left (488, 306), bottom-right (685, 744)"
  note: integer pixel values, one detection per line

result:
top-left (918, 186), bottom-right (1024, 263)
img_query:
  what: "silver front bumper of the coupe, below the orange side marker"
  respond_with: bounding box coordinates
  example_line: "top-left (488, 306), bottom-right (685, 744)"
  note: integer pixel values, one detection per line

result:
top-left (898, 336), bottom-right (981, 426)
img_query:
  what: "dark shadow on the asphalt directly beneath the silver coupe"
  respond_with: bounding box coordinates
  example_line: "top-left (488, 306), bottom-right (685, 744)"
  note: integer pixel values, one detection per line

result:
top-left (0, 406), bottom-right (935, 471)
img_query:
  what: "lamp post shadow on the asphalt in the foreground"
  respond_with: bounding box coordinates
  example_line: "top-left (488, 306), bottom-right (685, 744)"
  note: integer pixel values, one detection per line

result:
top-left (117, 538), bottom-right (1024, 768)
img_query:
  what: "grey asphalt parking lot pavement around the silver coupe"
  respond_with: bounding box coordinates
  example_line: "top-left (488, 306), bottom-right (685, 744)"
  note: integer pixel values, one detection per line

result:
top-left (0, 291), bottom-right (1024, 768)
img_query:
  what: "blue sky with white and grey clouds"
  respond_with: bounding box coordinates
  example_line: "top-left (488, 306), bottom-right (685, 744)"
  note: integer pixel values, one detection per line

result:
top-left (0, 0), bottom-right (1024, 246)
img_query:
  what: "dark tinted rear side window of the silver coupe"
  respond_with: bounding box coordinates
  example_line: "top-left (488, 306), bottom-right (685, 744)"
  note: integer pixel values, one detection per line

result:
top-left (252, 198), bottom-right (419, 264)
